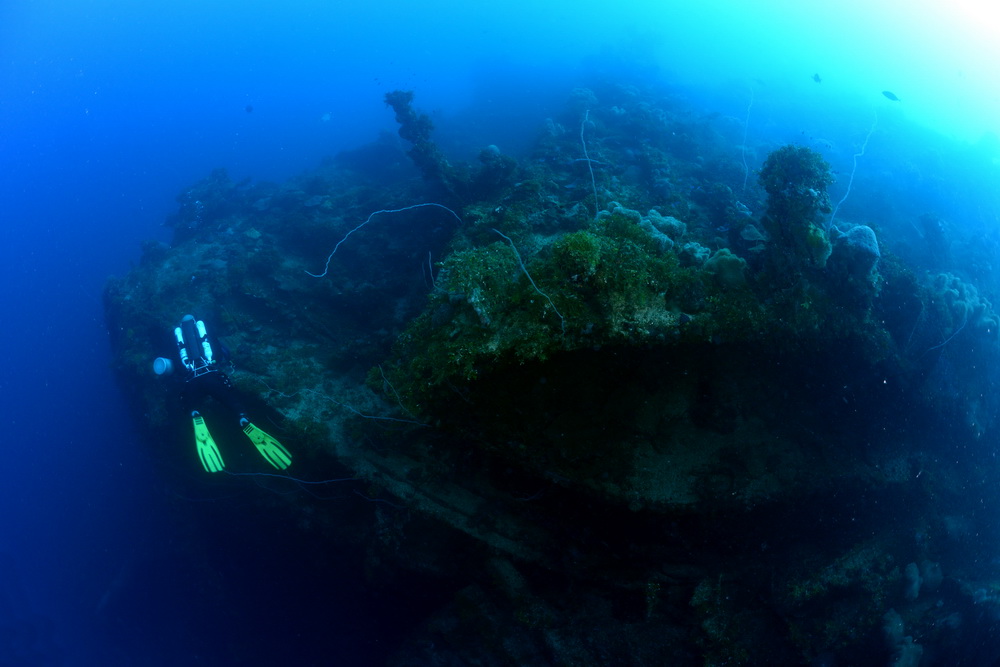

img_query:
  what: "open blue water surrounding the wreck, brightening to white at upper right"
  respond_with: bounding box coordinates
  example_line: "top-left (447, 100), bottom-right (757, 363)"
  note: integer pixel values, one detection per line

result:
top-left (0, 0), bottom-right (1000, 665)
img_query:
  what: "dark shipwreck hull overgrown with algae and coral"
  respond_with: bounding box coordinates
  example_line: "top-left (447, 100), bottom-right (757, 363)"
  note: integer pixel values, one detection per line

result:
top-left (105, 85), bottom-right (1000, 665)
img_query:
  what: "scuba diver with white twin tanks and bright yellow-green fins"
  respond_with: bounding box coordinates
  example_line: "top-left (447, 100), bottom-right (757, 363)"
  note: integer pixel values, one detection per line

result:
top-left (153, 315), bottom-right (292, 472)
